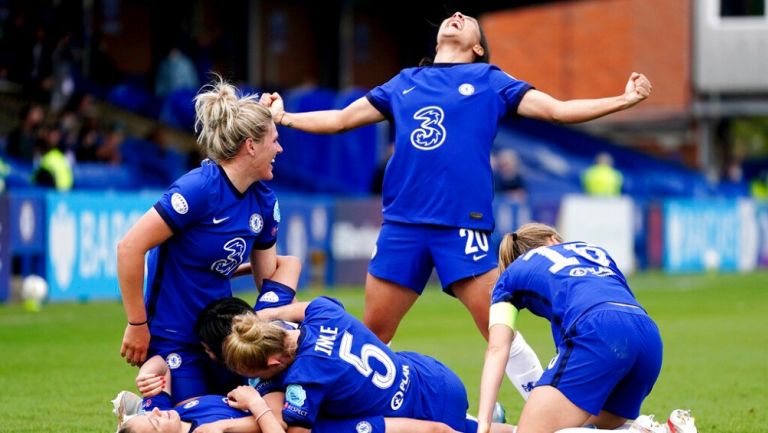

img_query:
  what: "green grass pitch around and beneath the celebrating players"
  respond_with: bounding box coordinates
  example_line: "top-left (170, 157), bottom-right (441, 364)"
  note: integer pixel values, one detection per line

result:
top-left (0, 272), bottom-right (768, 433)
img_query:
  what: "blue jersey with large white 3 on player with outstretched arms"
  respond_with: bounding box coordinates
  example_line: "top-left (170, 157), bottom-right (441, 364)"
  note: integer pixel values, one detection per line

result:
top-left (367, 63), bottom-right (532, 230)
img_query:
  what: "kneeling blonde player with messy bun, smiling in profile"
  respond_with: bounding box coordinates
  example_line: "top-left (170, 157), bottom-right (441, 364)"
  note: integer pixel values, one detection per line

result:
top-left (117, 77), bottom-right (282, 402)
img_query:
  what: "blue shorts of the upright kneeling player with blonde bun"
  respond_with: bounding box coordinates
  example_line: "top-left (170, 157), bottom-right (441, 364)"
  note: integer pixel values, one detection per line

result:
top-left (147, 337), bottom-right (247, 405)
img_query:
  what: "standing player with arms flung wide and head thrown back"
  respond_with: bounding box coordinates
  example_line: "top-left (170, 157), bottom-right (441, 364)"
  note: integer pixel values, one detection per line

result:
top-left (260, 12), bottom-right (651, 352)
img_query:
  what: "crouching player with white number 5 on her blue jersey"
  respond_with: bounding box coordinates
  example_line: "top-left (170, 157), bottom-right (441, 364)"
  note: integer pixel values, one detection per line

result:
top-left (222, 297), bottom-right (512, 433)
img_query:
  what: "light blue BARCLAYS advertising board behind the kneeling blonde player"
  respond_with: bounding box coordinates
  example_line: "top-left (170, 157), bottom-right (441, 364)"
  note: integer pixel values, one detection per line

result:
top-left (46, 192), bottom-right (159, 301)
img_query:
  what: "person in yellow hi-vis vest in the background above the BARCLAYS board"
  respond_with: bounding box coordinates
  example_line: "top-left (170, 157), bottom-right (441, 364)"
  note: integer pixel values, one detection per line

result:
top-left (33, 126), bottom-right (74, 191)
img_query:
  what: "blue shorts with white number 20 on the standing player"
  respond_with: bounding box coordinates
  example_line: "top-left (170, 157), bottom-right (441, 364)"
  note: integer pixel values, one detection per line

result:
top-left (368, 221), bottom-right (496, 295)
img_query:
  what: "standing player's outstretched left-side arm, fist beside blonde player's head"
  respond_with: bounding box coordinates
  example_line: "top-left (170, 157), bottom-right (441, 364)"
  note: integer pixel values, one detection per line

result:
top-left (261, 93), bottom-right (384, 134)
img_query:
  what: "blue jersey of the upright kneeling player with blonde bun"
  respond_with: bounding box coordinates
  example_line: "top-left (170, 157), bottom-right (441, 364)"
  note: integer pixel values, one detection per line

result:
top-left (145, 160), bottom-right (280, 343)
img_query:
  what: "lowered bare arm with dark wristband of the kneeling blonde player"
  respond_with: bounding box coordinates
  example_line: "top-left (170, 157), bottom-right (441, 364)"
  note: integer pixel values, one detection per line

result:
top-left (117, 208), bottom-right (173, 365)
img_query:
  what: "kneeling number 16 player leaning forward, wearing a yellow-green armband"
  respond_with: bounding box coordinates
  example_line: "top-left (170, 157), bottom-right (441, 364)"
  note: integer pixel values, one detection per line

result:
top-left (478, 223), bottom-right (668, 433)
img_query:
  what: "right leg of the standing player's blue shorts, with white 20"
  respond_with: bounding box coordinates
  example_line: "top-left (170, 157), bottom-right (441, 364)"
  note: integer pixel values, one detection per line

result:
top-left (429, 227), bottom-right (497, 294)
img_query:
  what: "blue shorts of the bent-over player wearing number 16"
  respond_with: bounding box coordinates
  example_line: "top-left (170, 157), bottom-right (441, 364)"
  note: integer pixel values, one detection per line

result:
top-left (536, 307), bottom-right (663, 419)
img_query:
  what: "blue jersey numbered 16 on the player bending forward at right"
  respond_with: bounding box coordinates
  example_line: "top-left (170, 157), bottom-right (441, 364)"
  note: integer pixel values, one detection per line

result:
top-left (491, 242), bottom-right (640, 345)
